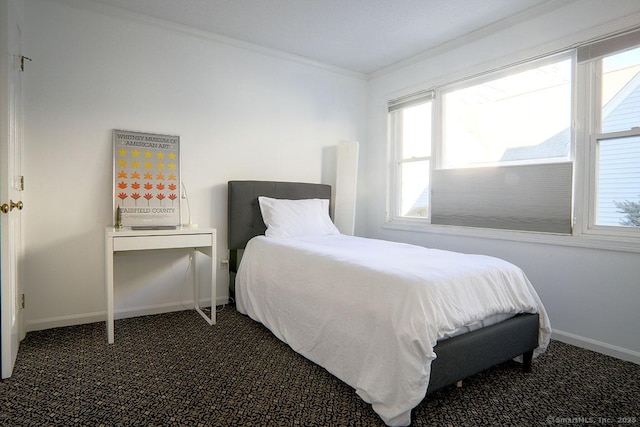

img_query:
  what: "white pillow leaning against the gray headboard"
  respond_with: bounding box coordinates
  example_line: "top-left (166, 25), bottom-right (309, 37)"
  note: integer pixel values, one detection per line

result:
top-left (258, 196), bottom-right (340, 238)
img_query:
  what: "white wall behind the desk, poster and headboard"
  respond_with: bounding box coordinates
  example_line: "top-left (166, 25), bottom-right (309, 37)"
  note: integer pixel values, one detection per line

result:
top-left (24, 0), bottom-right (367, 330)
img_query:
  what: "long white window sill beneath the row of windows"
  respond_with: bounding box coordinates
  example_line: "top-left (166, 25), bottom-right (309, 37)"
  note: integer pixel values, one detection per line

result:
top-left (382, 219), bottom-right (640, 253)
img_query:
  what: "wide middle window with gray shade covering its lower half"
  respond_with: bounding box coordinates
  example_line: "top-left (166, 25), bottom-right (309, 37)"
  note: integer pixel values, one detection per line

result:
top-left (431, 54), bottom-right (573, 234)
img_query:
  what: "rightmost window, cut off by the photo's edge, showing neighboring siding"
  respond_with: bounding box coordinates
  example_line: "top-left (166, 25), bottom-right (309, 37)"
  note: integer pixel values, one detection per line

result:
top-left (578, 32), bottom-right (640, 236)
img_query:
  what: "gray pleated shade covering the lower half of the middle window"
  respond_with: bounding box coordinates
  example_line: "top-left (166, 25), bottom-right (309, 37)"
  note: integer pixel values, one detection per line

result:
top-left (431, 162), bottom-right (573, 234)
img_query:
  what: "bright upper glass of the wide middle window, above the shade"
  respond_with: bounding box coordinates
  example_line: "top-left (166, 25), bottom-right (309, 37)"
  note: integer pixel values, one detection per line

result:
top-left (439, 55), bottom-right (572, 168)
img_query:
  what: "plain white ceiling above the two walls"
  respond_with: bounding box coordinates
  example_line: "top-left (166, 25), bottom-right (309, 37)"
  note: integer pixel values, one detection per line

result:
top-left (92, 0), bottom-right (556, 74)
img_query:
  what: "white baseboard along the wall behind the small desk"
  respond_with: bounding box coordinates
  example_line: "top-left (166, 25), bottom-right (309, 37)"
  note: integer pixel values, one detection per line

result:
top-left (25, 297), bottom-right (228, 332)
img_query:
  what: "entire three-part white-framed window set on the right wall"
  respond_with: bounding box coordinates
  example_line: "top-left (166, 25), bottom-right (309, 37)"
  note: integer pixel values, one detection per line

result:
top-left (389, 29), bottom-right (640, 247)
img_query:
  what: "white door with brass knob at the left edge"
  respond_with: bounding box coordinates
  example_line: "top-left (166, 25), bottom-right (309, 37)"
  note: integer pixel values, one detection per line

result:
top-left (0, 0), bottom-right (24, 378)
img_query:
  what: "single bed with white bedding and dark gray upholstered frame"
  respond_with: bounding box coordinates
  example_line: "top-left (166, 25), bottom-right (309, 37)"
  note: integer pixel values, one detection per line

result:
top-left (228, 181), bottom-right (551, 425)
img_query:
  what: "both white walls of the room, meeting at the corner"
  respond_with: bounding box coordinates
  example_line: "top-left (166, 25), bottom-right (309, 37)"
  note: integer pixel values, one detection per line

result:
top-left (23, 0), bottom-right (640, 361)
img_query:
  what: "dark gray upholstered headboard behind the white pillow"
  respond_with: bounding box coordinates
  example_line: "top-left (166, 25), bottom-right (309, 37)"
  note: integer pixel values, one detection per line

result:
top-left (227, 181), bottom-right (331, 298)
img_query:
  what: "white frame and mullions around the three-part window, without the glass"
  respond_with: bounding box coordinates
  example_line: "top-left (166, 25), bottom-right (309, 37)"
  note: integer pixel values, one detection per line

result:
top-left (383, 28), bottom-right (640, 249)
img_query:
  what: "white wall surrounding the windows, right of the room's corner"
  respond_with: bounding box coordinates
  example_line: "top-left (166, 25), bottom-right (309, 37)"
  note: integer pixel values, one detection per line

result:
top-left (358, 0), bottom-right (640, 363)
